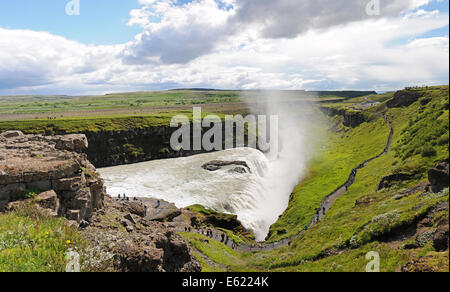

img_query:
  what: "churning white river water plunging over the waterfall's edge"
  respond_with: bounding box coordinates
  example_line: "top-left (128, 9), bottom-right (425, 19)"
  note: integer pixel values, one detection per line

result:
top-left (99, 148), bottom-right (276, 240)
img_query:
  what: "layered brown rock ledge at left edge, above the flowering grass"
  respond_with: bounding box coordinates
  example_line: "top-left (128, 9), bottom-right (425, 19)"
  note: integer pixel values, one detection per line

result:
top-left (0, 131), bottom-right (105, 222)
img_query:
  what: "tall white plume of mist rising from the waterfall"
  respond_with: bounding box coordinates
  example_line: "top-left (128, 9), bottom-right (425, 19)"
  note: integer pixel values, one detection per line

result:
top-left (243, 91), bottom-right (324, 240)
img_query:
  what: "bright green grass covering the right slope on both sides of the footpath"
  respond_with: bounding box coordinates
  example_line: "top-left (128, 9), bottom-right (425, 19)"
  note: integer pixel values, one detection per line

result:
top-left (252, 87), bottom-right (448, 271)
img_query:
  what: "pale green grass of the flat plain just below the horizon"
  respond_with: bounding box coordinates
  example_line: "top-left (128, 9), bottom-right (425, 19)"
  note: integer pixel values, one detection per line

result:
top-left (0, 90), bottom-right (374, 115)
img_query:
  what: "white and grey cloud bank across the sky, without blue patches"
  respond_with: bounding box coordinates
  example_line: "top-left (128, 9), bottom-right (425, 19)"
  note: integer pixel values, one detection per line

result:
top-left (0, 0), bottom-right (449, 94)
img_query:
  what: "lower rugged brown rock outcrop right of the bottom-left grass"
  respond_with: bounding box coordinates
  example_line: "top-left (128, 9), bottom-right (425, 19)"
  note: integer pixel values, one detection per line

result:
top-left (82, 196), bottom-right (202, 272)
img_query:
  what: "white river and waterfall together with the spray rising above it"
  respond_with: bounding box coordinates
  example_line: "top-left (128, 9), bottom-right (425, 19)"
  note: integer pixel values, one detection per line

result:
top-left (99, 100), bottom-right (321, 241)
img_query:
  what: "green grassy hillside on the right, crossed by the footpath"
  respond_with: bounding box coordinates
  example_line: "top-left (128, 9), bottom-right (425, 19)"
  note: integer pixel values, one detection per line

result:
top-left (182, 86), bottom-right (449, 272)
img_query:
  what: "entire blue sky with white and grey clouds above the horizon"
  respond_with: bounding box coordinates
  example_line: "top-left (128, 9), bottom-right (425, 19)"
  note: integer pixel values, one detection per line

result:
top-left (0, 0), bottom-right (449, 95)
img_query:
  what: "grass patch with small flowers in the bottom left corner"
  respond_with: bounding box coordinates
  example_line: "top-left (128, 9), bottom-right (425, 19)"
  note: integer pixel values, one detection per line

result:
top-left (0, 206), bottom-right (87, 272)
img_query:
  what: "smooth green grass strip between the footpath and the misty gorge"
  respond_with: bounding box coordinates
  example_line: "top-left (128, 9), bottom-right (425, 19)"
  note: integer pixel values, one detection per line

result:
top-left (269, 112), bottom-right (389, 241)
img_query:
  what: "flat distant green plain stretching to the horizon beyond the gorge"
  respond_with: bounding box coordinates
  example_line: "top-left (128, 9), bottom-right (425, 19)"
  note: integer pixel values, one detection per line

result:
top-left (0, 90), bottom-right (358, 121)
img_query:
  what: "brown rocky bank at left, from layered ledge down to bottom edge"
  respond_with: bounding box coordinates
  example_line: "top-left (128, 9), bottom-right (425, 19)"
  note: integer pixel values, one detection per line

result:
top-left (0, 131), bottom-right (201, 272)
